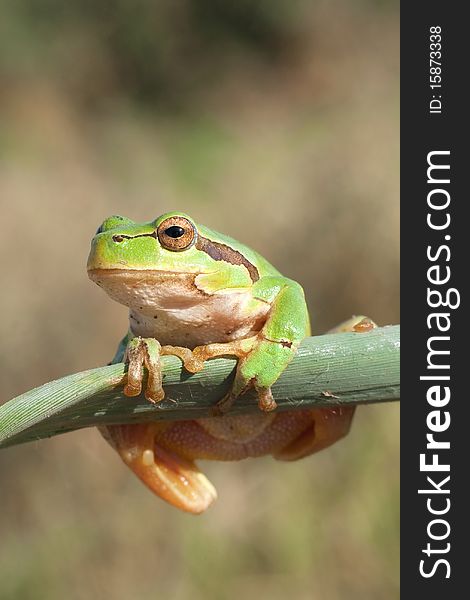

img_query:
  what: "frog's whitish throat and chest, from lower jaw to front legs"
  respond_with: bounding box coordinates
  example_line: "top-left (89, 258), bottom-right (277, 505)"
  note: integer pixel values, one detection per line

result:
top-left (90, 269), bottom-right (270, 348)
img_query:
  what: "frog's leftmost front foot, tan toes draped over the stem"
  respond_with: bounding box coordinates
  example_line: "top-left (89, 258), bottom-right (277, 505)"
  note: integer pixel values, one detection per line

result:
top-left (124, 337), bottom-right (165, 403)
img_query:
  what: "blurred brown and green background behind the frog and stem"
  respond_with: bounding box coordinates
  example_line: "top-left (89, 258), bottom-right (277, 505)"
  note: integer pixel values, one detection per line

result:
top-left (0, 0), bottom-right (399, 600)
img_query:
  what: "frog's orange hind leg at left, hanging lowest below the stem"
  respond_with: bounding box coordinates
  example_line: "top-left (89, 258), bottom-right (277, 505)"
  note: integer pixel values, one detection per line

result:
top-left (100, 423), bottom-right (217, 514)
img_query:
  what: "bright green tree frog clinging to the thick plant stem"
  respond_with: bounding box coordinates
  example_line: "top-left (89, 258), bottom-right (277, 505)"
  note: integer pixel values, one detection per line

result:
top-left (87, 212), bottom-right (373, 514)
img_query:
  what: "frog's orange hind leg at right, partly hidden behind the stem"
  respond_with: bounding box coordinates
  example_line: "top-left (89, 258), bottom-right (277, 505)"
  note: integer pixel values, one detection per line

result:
top-left (273, 316), bottom-right (377, 460)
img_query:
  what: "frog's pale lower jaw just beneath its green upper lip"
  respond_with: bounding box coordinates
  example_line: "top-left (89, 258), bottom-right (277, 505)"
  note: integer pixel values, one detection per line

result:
top-left (88, 269), bottom-right (207, 312)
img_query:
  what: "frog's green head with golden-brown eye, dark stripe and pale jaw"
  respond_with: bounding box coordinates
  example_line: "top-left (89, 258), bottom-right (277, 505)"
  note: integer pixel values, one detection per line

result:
top-left (87, 212), bottom-right (259, 312)
